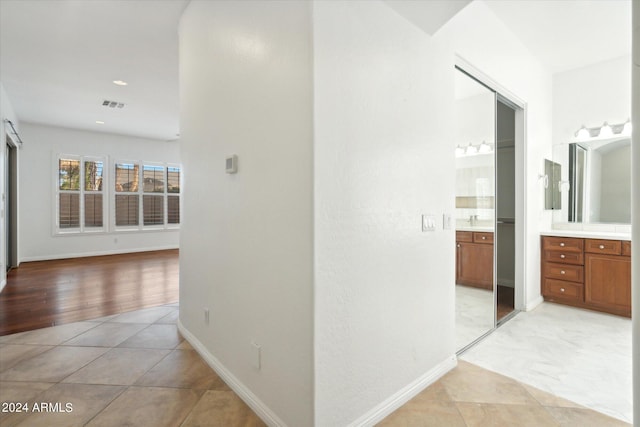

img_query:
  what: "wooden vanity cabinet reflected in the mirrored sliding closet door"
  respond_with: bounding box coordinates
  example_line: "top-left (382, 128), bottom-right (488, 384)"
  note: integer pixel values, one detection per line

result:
top-left (456, 231), bottom-right (493, 289)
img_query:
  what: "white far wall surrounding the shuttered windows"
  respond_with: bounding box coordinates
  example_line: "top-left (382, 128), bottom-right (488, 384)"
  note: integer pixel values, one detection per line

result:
top-left (18, 122), bottom-right (180, 261)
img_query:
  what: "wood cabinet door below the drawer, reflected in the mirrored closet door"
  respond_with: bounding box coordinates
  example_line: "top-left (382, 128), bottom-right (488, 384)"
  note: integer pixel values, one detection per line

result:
top-left (457, 242), bottom-right (493, 289)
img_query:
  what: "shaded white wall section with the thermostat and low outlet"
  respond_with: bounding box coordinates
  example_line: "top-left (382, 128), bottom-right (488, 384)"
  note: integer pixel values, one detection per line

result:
top-left (179, 1), bottom-right (313, 427)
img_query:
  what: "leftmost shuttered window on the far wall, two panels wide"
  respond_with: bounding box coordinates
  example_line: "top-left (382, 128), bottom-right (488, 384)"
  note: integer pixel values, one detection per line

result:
top-left (56, 156), bottom-right (104, 232)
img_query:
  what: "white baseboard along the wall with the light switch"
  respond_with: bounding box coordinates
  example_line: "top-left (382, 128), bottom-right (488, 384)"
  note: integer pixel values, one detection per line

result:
top-left (349, 354), bottom-right (458, 427)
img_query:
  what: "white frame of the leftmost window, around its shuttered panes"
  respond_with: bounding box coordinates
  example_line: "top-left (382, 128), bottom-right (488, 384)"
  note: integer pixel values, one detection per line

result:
top-left (52, 153), bottom-right (109, 236)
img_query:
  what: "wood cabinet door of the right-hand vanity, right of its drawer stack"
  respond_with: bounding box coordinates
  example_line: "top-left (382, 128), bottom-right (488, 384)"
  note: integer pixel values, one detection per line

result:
top-left (585, 254), bottom-right (631, 316)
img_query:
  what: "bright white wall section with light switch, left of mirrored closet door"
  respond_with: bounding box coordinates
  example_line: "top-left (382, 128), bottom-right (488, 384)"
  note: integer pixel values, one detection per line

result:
top-left (314, 1), bottom-right (455, 426)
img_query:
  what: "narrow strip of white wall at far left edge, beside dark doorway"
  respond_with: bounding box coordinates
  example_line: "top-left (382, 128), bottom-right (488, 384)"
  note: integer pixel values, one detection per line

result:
top-left (0, 82), bottom-right (20, 291)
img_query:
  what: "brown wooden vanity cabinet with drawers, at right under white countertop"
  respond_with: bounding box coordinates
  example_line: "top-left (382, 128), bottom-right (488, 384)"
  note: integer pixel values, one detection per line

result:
top-left (542, 236), bottom-right (631, 317)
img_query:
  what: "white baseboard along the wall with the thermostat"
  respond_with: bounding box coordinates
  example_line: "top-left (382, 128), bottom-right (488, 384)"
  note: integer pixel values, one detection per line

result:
top-left (176, 319), bottom-right (287, 427)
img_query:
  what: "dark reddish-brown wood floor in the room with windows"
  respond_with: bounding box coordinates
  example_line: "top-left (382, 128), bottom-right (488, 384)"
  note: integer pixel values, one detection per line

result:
top-left (0, 249), bottom-right (178, 336)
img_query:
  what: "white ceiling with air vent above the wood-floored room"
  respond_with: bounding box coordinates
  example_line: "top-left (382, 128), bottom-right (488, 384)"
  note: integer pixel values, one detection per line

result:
top-left (0, 0), bottom-right (188, 140)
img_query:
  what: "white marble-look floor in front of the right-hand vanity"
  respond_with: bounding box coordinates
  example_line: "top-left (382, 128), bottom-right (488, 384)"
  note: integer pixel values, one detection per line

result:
top-left (460, 302), bottom-right (633, 423)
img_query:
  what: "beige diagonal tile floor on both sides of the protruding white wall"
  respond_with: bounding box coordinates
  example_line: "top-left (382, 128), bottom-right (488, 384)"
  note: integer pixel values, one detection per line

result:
top-left (0, 304), bottom-right (628, 427)
